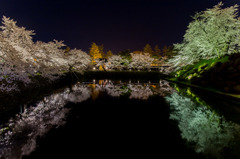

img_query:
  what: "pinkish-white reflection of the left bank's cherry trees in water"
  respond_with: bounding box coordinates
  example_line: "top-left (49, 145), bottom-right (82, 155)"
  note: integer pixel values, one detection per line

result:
top-left (0, 84), bottom-right (90, 159)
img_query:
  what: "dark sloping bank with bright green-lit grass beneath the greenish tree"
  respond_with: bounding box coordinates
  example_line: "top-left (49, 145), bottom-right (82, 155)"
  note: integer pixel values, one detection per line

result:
top-left (167, 53), bottom-right (240, 100)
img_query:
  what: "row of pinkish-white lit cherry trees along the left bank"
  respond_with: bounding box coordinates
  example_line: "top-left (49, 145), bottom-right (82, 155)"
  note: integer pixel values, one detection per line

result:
top-left (0, 16), bottom-right (90, 92)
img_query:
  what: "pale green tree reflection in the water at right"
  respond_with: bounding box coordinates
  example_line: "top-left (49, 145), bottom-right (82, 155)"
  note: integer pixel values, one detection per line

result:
top-left (166, 93), bottom-right (240, 158)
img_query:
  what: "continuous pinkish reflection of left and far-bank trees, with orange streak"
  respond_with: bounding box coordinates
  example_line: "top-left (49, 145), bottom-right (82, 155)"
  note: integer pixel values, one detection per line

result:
top-left (0, 80), bottom-right (174, 159)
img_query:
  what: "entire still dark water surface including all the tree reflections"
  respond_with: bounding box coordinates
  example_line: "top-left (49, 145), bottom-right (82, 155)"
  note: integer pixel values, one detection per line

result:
top-left (0, 80), bottom-right (240, 159)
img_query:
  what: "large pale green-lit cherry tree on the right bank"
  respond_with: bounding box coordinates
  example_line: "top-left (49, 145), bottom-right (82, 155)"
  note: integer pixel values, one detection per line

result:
top-left (169, 2), bottom-right (240, 67)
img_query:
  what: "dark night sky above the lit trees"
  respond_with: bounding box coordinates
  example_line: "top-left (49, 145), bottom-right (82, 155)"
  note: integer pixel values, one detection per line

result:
top-left (0, 0), bottom-right (240, 53)
